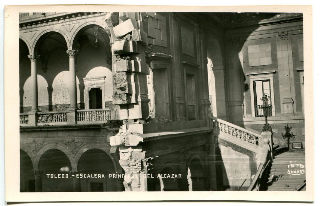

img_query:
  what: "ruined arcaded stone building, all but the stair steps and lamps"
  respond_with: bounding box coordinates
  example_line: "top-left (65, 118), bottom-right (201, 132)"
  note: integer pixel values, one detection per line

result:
top-left (19, 12), bottom-right (304, 191)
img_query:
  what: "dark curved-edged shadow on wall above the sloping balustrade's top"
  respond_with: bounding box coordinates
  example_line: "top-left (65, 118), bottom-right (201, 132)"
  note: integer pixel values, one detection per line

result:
top-left (224, 13), bottom-right (277, 127)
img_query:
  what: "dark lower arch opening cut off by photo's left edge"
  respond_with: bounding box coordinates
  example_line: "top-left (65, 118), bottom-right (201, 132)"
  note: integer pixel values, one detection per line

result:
top-left (20, 149), bottom-right (35, 192)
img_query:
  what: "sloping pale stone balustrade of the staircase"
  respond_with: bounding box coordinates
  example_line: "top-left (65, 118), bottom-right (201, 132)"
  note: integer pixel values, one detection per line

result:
top-left (216, 119), bottom-right (262, 147)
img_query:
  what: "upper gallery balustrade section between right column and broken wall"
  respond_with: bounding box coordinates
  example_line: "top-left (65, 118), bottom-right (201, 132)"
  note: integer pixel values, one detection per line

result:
top-left (77, 109), bottom-right (111, 123)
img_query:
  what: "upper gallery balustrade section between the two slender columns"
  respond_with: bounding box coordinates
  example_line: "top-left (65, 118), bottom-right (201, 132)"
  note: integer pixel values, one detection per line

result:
top-left (37, 112), bottom-right (67, 124)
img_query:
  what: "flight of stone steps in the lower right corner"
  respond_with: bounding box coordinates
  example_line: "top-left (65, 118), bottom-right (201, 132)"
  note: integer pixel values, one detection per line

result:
top-left (266, 151), bottom-right (306, 191)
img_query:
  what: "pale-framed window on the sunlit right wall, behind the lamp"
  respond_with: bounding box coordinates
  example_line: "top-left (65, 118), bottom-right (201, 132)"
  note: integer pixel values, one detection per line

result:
top-left (250, 73), bottom-right (275, 117)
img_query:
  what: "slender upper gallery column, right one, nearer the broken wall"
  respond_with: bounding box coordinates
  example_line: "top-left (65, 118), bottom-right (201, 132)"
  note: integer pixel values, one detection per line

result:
top-left (67, 50), bottom-right (77, 123)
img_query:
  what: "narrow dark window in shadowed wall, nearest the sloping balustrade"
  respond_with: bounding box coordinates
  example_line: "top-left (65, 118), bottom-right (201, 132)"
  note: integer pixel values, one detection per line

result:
top-left (186, 74), bottom-right (197, 120)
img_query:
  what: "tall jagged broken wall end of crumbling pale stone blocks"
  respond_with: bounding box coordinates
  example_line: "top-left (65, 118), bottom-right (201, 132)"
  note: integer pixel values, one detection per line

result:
top-left (105, 12), bottom-right (148, 191)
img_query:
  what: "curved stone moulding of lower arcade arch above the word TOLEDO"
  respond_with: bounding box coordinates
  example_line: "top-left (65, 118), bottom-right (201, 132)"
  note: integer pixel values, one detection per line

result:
top-left (34, 143), bottom-right (76, 170)
